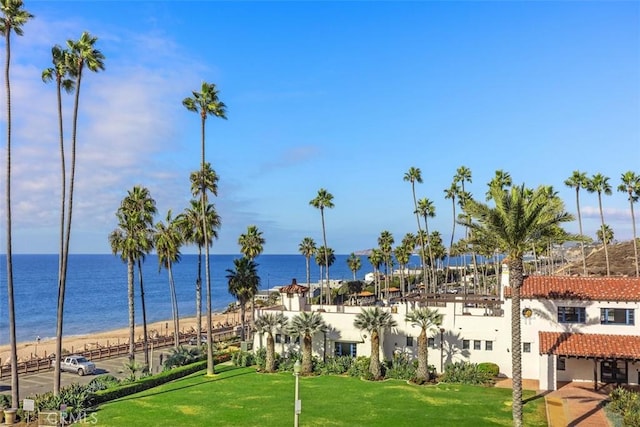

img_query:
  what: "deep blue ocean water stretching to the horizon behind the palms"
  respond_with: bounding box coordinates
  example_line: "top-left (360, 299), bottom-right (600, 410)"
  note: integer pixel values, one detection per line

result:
top-left (0, 254), bottom-right (373, 344)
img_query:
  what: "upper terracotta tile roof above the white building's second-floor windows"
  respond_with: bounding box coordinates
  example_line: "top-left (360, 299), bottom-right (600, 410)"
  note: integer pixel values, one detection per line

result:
top-left (505, 276), bottom-right (640, 301)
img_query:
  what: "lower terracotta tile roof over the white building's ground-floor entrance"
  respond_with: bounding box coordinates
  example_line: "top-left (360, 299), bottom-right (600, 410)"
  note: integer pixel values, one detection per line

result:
top-left (538, 332), bottom-right (640, 360)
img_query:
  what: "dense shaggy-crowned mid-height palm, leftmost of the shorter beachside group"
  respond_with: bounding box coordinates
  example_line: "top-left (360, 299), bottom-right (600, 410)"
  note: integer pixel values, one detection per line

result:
top-left (109, 186), bottom-right (157, 360)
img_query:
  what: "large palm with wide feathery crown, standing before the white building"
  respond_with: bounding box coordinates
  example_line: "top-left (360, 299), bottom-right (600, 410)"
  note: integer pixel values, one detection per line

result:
top-left (464, 185), bottom-right (573, 426)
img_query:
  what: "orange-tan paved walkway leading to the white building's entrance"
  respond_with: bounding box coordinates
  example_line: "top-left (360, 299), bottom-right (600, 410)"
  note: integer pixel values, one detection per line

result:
top-left (496, 378), bottom-right (611, 427)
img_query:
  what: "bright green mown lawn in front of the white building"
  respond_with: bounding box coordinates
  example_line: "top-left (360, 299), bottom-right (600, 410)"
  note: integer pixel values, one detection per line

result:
top-left (91, 366), bottom-right (547, 427)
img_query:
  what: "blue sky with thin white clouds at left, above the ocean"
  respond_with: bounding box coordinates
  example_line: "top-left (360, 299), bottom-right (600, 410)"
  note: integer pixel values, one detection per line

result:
top-left (0, 0), bottom-right (640, 254)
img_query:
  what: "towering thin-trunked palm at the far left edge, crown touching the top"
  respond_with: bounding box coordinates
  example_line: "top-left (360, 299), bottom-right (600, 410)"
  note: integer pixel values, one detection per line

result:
top-left (0, 0), bottom-right (33, 408)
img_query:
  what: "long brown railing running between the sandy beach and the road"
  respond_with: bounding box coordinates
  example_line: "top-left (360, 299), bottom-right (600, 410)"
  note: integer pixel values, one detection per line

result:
top-left (0, 325), bottom-right (251, 378)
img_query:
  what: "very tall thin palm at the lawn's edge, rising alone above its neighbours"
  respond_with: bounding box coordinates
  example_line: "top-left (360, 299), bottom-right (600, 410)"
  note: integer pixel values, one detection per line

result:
top-left (182, 82), bottom-right (227, 375)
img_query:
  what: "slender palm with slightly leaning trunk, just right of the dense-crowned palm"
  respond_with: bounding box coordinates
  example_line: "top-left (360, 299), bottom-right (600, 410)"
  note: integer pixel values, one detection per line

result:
top-left (153, 210), bottom-right (182, 348)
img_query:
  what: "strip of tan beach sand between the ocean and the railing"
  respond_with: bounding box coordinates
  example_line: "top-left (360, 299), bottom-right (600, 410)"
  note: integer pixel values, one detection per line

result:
top-left (0, 310), bottom-right (251, 365)
